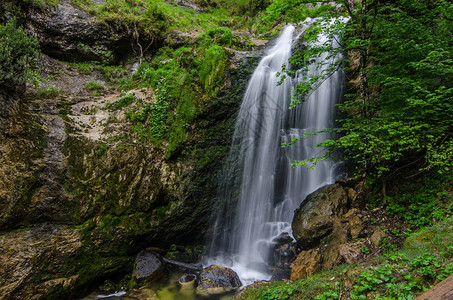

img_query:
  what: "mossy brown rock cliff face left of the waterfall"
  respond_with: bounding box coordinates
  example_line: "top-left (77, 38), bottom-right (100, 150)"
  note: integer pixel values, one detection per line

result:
top-left (0, 1), bottom-right (260, 299)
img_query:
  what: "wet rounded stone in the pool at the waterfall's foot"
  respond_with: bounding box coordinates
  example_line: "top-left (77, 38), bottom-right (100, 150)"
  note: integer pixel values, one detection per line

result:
top-left (197, 265), bottom-right (242, 295)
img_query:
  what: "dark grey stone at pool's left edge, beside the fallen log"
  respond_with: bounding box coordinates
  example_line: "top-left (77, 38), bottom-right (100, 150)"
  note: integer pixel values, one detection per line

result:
top-left (133, 250), bottom-right (165, 281)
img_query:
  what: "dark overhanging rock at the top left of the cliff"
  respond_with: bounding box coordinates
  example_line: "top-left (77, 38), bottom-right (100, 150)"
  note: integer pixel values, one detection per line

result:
top-left (25, 0), bottom-right (136, 62)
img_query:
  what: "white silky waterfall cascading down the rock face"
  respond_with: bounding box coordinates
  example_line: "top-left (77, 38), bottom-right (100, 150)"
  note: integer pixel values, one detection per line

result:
top-left (207, 20), bottom-right (343, 284)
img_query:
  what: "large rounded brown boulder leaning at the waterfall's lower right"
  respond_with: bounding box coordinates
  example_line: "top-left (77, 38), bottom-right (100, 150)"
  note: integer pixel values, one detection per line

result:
top-left (292, 184), bottom-right (348, 248)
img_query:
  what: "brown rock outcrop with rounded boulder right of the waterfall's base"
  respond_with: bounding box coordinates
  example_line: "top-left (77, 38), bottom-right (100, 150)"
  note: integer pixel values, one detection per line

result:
top-left (291, 180), bottom-right (380, 280)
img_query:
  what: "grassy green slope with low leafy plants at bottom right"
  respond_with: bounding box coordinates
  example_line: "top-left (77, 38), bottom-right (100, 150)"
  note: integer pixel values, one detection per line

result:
top-left (240, 218), bottom-right (453, 300)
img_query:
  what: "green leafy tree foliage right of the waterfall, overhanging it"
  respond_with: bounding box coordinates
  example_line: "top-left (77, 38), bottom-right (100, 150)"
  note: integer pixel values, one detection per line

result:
top-left (284, 0), bottom-right (453, 176)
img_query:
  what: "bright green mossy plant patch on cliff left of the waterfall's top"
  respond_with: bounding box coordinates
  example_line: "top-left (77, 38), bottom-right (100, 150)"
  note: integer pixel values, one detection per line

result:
top-left (120, 27), bottom-right (235, 158)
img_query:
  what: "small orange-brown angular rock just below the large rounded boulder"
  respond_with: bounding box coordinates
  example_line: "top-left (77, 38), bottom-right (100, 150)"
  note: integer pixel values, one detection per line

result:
top-left (291, 249), bottom-right (322, 280)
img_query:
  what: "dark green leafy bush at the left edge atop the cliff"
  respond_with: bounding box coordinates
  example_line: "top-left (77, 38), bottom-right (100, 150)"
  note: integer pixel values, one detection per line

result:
top-left (0, 20), bottom-right (40, 88)
